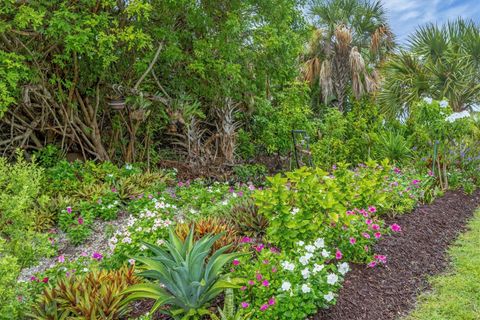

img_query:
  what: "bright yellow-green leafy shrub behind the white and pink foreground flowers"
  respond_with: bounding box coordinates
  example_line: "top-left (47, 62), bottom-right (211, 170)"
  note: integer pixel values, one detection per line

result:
top-left (251, 162), bottom-right (390, 249)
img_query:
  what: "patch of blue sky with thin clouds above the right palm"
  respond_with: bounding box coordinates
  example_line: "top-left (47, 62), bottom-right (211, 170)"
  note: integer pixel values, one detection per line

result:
top-left (382, 0), bottom-right (480, 43)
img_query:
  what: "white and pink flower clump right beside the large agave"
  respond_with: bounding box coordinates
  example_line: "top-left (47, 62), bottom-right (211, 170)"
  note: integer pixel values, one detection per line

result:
top-left (233, 238), bottom-right (349, 319)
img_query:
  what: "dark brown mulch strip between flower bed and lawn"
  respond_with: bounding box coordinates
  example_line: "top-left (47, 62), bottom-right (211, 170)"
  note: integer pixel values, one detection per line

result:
top-left (313, 191), bottom-right (480, 320)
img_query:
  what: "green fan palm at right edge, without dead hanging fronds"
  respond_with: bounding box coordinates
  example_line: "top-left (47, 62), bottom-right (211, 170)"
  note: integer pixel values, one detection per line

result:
top-left (378, 19), bottom-right (480, 116)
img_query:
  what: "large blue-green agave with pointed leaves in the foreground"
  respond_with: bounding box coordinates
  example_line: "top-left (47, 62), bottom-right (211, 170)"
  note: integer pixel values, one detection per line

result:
top-left (124, 228), bottom-right (246, 319)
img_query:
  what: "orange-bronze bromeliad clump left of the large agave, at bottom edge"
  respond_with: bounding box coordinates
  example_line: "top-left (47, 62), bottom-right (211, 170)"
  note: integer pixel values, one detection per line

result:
top-left (30, 267), bottom-right (140, 320)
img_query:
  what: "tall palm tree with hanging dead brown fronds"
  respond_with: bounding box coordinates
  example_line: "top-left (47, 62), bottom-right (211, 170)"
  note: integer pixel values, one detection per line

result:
top-left (304, 0), bottom-right (394, 111)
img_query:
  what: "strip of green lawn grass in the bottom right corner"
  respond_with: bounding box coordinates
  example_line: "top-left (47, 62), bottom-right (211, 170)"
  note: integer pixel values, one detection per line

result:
top-left (404, 209), bottom-right (480, 320)
